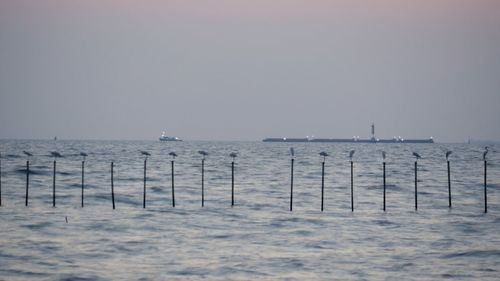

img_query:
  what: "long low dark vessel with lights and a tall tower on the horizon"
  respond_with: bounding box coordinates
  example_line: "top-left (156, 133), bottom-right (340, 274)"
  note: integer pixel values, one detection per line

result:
top-left (262, 124), bottom-right (434, 143)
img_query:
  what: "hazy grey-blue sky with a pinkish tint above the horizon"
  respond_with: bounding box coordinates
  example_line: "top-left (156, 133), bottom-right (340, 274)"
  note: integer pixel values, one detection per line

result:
top-left (0, 0), bottom-right (500, 142)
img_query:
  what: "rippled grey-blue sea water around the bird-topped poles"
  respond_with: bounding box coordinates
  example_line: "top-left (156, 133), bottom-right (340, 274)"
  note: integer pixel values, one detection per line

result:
top-left (0, 140), bottom-right (500, 280)
